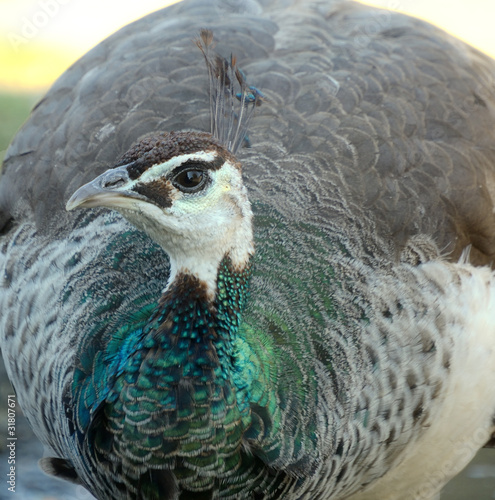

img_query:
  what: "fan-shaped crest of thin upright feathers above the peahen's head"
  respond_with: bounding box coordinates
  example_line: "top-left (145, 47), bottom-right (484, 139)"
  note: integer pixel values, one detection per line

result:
top-left (196, 29), bottom-right (264, 154)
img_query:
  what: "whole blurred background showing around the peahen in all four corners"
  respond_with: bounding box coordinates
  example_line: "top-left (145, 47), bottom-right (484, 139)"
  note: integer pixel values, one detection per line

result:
top-left (0, 0), bottom-right (495, 500)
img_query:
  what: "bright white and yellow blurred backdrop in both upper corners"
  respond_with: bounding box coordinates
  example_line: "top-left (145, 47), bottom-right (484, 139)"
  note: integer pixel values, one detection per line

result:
top-left (0, 0), bottom-right (495, 92)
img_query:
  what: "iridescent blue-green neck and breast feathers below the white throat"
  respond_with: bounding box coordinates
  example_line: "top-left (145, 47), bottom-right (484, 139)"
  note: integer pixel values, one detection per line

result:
top-left (72, 244), bottom-right (316, 497)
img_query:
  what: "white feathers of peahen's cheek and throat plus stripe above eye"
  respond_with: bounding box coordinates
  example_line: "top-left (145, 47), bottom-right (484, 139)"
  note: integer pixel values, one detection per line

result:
top-left (118, 157), bottom-right (254, 296)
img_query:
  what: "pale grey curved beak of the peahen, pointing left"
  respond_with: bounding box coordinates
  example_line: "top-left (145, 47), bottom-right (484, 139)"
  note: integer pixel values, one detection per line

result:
top-left (65, 165), bottom-right (143, 210)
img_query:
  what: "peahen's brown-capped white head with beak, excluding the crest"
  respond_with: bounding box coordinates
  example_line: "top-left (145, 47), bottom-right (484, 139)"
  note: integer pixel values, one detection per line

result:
top-left (67, 131), bottom-right (253, 288)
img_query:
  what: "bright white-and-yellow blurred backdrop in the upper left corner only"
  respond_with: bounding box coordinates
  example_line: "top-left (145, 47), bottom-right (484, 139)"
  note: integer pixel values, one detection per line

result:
top-left (0, 0), bottom-right (181, 92)
